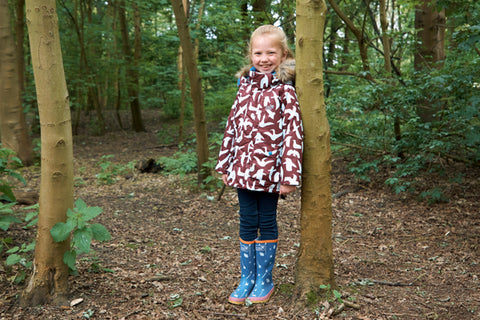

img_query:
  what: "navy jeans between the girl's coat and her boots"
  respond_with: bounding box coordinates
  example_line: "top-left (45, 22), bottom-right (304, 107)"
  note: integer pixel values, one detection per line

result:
top-left (237, 189), bottom-right (278, 241)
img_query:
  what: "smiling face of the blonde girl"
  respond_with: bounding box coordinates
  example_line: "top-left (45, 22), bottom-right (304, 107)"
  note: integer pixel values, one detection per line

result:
top-left (250, 34), bottom-right (287, 73)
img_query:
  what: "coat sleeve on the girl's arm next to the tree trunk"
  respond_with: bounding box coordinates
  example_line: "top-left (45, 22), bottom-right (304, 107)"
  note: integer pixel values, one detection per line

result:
top-left (280, 85), bottom-right (303, 186)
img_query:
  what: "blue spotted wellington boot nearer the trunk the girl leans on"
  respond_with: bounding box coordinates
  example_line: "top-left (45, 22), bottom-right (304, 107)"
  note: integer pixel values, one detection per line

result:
top-left (248, 239), bottom-right (278, 303)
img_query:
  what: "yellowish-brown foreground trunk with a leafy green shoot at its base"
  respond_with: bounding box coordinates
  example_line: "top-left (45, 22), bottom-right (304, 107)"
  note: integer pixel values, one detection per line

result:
top-left (21, 0), bottom-right (73, 306)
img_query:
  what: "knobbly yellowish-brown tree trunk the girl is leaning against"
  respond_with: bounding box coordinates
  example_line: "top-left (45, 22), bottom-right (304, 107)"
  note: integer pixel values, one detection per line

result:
top-left (294, 0), bottom-right (335, 303)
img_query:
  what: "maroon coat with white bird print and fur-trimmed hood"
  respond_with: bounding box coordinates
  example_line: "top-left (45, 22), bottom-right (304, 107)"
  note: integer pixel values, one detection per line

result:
top-left (215, 61), bottom-right (303, 193)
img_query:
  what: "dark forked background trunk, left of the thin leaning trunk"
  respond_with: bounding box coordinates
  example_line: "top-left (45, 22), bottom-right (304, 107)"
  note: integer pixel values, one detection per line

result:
top-left (118, 1), bottom-right (145, 132)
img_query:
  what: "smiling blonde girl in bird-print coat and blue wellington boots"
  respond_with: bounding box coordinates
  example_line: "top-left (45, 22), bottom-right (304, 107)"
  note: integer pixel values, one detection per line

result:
top-left (215, 25), bottom-right (303, 304)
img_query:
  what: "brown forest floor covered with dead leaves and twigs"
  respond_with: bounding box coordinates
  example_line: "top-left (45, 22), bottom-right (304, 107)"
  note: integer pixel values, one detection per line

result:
top-left (0, 109), bottom-right (480, 320)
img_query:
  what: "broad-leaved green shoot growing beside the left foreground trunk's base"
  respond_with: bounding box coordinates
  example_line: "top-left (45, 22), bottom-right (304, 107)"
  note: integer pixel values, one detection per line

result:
top-left (50, 199), bottom-right (111, 273)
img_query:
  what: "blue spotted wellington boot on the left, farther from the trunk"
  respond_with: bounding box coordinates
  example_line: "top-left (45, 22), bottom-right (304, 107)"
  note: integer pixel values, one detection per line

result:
top-left (228, 239), bottom-right (256, 304)
